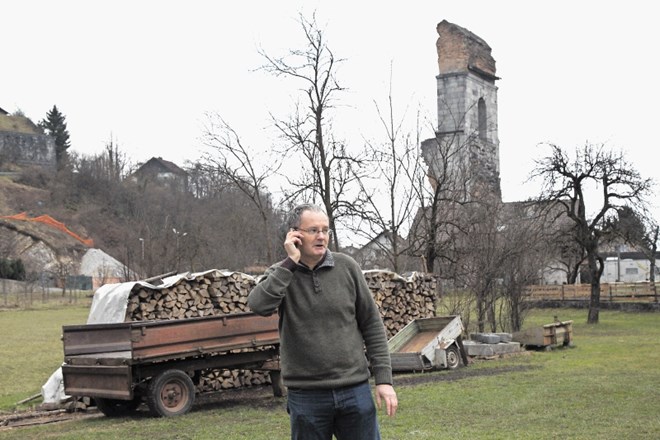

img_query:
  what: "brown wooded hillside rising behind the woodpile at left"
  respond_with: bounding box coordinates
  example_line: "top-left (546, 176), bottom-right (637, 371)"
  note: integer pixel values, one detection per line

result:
top-left (0, 162), bottom-right (290, 278)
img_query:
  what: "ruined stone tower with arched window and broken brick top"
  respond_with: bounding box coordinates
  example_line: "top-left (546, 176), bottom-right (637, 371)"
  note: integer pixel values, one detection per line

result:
top-left (422, 20), bottom-right (501, 199)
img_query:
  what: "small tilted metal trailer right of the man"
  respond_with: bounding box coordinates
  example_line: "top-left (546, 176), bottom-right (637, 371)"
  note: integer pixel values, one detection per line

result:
top-left (387, 316), bottom-right (468, 371)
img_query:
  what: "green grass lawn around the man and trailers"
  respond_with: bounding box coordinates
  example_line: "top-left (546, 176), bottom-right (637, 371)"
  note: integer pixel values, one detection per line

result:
top-left (0, 309), bottom-right (660, 440)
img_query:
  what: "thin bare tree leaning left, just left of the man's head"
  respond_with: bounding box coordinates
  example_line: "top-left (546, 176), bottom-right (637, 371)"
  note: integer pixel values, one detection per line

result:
top-left (204, 114), bottom-right (281, 261)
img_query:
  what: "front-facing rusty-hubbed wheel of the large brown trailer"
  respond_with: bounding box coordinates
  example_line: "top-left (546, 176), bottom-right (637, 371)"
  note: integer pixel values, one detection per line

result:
top-left (147, 370), bottom-right (195, 417)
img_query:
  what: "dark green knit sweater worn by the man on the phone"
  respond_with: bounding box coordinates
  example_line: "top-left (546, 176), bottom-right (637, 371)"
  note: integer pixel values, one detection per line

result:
top-left (248, 251), bottom-right (392, 389)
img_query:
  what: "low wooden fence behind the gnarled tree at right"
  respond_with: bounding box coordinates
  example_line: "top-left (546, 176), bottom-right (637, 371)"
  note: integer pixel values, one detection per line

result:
top-left (525, 282), bottom-right (658, 303)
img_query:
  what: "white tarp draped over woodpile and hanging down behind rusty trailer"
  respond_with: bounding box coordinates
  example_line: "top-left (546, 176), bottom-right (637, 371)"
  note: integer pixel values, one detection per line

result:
top-left (41, 269), bottom-right (232, 403)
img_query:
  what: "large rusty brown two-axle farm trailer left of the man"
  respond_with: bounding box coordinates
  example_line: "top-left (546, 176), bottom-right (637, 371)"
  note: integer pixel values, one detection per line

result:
top-left (62, 313), bottom-right (284, 417)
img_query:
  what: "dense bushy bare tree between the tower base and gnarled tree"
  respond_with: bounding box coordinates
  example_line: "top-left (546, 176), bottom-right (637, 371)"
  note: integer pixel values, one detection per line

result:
top-left (443, 194), bottom-right (550, 332)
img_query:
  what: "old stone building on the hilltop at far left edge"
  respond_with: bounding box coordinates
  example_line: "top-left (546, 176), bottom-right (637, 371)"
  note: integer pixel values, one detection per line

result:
top-left (0, 108), bottom-right (57, 169)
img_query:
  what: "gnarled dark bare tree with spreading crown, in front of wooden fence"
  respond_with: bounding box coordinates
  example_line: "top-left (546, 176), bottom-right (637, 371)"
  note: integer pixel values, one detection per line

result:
top-left (530, 143), bottom-right (652, 324)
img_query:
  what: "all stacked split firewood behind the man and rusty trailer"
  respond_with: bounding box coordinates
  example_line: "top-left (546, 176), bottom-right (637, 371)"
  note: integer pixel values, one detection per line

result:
top-left (126, 270), bottom-right (437, 392)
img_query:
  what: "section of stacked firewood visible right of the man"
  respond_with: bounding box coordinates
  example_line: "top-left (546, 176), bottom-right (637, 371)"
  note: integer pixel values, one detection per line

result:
top-left (364, 270), bottom-right (437, 339)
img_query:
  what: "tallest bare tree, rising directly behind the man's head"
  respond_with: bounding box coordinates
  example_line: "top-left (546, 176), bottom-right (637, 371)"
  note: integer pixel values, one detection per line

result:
top-left (260, 15), bottom-right (363, 249)
